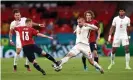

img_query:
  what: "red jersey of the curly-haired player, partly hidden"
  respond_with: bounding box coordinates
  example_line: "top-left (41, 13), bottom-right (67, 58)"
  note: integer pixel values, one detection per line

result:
top-left (87, 19), bottom-right (98, 42)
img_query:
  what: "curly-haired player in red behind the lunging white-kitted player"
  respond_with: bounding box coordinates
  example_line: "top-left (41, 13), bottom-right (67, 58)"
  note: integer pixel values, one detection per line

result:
top-left (82, 10), bottom-right (100, 70)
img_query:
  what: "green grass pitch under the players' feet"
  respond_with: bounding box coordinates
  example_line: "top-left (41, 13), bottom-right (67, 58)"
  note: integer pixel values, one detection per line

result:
top-left (1, 57), bottom-right (133, 80)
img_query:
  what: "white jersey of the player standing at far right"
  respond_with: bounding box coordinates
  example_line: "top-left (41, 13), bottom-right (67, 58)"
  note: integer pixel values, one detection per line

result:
top-left (112, 16), bottom-right (130, 37)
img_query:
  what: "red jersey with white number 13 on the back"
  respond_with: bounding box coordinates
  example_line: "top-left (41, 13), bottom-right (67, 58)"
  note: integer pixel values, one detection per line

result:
top-left (14, 26), bottom-right (38, 46)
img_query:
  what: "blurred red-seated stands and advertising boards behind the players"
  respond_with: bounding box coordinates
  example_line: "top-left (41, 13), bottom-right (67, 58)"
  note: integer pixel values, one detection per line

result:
top-left (0, 1), bottom-right (133, 58)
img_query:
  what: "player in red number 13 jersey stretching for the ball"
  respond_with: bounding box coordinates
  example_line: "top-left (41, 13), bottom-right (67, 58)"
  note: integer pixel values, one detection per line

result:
top-left (11, 19), bottom-right (58, 75)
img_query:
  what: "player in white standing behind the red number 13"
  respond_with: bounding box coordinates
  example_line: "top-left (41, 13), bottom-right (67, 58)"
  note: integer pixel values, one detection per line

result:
top-left (9, 9), bottom-right (44, 71)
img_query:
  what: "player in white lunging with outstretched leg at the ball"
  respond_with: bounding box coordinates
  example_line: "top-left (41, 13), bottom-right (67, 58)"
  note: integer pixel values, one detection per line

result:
top-left (53, 18), bottom-right (104, 73)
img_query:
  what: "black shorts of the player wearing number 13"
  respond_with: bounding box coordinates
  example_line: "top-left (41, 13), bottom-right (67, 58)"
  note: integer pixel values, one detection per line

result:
top-left (23, 44), bottom-right (42, 62)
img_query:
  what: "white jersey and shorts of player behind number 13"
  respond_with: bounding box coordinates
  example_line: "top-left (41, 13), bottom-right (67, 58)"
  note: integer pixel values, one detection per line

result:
top-left (10, 17), bottom-right (27, 48)
